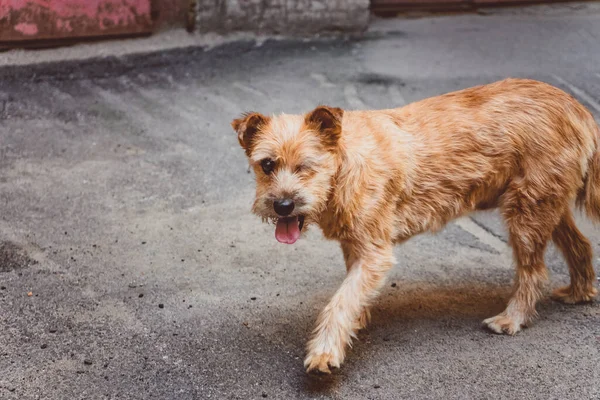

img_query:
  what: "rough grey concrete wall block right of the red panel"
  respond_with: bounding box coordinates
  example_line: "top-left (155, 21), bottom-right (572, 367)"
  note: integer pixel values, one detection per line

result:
top-left (196, 0), bottom-right (369, 34)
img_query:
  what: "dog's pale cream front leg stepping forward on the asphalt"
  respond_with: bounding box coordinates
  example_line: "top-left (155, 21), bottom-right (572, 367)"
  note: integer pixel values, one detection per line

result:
top-left (304, 245), bottom-right (394, 373)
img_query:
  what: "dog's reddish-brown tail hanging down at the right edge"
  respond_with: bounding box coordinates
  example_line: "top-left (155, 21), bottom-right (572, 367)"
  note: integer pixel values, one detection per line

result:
top-left (577, 119), bottom-right (600, 223)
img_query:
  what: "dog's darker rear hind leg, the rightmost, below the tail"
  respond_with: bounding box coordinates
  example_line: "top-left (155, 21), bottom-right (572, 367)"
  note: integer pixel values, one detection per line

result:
top-left (552, 210), bottom-right (598, 304)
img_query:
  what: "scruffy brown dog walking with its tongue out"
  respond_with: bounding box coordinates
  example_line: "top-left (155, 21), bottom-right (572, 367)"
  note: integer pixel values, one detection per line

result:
top-left (232, 79), bottom-right (600, 373)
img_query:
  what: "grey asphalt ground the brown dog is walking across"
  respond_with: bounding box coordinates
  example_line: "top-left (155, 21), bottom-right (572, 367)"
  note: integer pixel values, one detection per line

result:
top-left (0, 6), bottom-right (600, 400)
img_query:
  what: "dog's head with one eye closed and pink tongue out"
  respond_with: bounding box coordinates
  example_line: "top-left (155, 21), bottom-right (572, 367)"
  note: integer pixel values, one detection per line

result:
top-left (231, 106), bottom-right (344, 244)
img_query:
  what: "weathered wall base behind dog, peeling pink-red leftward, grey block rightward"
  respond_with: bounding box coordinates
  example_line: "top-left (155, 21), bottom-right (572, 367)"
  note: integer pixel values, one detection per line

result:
top-left (0, 0), bottom-right (369, 48)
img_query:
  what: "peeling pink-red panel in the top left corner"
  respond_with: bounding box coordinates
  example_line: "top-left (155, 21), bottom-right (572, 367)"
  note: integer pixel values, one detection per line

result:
top-left (0, 0), bottom-right (152, 42)
